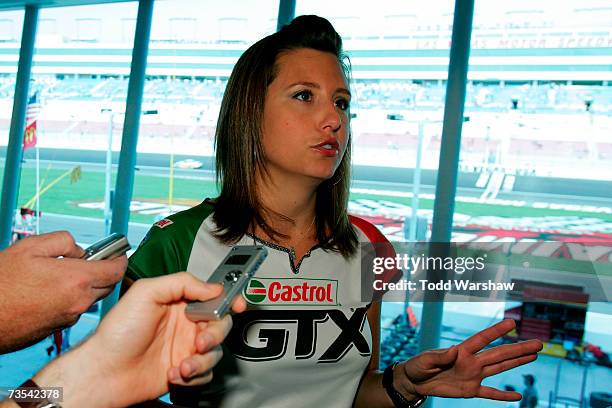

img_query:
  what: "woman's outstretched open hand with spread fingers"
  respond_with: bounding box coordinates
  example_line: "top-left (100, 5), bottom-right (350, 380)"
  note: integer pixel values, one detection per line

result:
top-left (398, 320), bottom-right (542, 401)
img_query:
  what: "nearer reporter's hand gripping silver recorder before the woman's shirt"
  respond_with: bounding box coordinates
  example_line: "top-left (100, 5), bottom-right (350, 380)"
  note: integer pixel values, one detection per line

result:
top-left (34, 273), bottom-right (246, 408)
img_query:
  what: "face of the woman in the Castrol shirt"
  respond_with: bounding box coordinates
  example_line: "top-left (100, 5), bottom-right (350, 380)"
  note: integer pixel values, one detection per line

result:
top-left (262, 48), bottom-right (351, 182)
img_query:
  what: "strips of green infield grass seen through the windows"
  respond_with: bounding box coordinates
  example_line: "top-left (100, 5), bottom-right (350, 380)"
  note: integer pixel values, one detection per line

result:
top-left (5, 168), bottom-right (612, 223)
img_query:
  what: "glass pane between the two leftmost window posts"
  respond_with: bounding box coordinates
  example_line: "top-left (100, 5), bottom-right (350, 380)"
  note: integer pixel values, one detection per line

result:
top-left (19, 3), bottom-right (137, 244)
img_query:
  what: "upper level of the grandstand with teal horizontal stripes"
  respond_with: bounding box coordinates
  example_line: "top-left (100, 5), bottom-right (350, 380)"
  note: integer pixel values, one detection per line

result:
top-left (0, 0), bottom-right (612, 81)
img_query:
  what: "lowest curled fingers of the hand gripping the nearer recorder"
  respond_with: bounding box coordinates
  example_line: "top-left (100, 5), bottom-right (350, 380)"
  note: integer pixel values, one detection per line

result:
top-left (168, 346), bottom-right (223, 385)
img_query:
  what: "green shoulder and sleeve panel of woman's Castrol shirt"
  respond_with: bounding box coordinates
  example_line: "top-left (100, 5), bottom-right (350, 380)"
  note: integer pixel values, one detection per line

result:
top-left (126, 201), bottom-right (213, 280)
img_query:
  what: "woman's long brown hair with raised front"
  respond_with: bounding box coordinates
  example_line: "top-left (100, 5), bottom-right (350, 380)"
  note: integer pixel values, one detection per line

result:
top-left (213, 16), bottom-right (358, 257)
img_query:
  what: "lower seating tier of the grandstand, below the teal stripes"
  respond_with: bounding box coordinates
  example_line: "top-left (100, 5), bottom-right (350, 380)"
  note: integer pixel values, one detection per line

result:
top-left (0, 76), bottom-right (612, 178)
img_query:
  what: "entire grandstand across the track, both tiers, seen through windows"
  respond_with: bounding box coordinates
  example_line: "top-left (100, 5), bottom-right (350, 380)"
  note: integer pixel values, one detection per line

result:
top-left (0, 0), bottom-right (612, 187)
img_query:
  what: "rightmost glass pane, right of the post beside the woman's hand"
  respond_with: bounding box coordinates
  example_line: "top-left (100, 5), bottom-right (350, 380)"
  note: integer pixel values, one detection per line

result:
top-left (462, 0), bottom-right (612, 405)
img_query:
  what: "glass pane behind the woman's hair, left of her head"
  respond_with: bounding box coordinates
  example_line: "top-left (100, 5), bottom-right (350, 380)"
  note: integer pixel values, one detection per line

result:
top-left (130, 0), bottom-right (278, 233)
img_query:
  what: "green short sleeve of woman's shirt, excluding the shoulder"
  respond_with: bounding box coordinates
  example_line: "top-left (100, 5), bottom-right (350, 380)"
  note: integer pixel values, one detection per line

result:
top-left (126, 225), bottom-right (187, 280)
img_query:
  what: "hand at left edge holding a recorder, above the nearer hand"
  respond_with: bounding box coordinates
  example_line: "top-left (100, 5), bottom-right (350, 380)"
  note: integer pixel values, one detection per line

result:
top-left (0, 231), bottom-right (127, 353)
